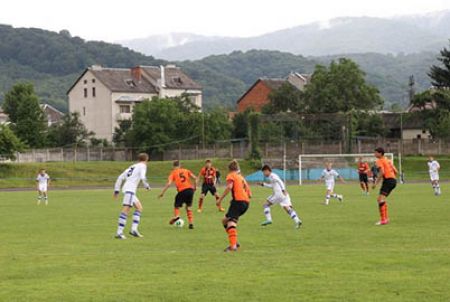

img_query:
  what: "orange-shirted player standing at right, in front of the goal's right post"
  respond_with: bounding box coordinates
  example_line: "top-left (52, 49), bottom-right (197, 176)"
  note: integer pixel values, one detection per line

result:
top-left (373, 147), bottom-right (398, 225)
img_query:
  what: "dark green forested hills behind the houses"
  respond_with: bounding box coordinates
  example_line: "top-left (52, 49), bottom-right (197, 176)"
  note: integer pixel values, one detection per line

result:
top-left (0, 25), bottom-right (440, 111)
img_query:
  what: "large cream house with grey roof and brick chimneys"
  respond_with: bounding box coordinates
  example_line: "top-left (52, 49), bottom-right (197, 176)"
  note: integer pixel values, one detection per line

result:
top-left (67, 65), bottom-right (202, 141)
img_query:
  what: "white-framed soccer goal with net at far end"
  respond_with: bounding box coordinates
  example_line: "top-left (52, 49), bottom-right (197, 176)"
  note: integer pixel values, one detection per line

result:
top-left (298, 153), bottom-right (394, 185)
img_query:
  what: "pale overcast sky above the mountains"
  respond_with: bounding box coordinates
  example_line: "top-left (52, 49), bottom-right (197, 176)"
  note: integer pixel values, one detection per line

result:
top-left (0, 0), bottom-right (450, 42)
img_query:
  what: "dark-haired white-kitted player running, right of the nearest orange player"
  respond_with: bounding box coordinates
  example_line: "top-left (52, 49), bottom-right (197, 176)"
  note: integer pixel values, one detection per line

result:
top-left (260, 165), bottom-right (302, 228)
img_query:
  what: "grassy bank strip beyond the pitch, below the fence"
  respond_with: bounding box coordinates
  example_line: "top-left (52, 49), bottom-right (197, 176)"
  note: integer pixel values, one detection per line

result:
top-left (0, 156), bottom-right (450, 188)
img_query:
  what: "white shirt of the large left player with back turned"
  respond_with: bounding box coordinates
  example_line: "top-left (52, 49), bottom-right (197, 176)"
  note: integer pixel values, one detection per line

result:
top-left (114, 163), bottom-right (150, 194)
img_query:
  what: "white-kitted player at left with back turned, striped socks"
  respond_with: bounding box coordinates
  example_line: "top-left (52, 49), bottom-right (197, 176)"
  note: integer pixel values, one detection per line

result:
top-left (114, 153), bottom-right (150, 239)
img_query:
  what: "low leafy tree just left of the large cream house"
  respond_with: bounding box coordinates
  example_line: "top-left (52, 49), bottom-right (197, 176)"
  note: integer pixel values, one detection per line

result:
top-left (48, 112), bottom-right (95, 147)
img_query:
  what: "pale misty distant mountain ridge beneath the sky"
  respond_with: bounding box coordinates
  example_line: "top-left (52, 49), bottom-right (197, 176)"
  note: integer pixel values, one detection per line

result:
top-left (123, 11), bottom-right (450, 60)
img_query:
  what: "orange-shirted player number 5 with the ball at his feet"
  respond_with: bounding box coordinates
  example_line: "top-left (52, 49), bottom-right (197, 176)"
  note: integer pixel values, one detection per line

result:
top-left (159, 160), bottom-right (197, 229)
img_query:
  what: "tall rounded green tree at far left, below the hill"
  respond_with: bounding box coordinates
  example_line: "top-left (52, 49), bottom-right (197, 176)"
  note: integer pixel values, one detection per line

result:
top-left (2, 83), bottom-right (47, 148)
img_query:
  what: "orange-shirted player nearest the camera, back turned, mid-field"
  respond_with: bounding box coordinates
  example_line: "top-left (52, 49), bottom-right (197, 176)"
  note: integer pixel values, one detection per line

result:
top-left (218, 160), bottom-right (252, 252)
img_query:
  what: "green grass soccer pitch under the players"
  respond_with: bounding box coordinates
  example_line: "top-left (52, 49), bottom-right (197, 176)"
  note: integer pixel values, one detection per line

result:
top-left (0, 184), bottom-right (450, 302)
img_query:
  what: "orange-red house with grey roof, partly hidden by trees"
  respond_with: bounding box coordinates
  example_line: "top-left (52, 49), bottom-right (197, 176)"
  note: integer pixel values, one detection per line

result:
top-left (237, 72), bottom-right (311, 112)
